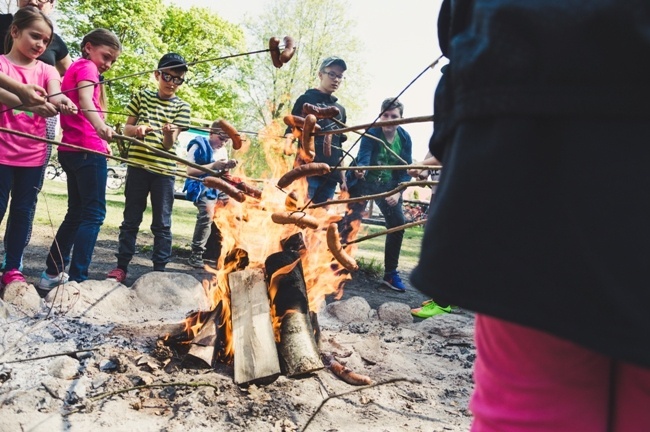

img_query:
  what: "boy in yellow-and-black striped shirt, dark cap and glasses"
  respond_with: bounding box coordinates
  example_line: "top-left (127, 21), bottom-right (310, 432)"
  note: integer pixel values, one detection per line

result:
top-left (107, 53), bottom-right (190, 282)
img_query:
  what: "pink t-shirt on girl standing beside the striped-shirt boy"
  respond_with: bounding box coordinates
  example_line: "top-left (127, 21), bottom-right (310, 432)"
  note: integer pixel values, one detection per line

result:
top-left (59, 59), bottom-right (108, 153)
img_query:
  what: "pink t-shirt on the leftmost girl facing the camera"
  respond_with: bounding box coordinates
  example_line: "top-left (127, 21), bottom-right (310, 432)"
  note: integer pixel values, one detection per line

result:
top-left (0, 55), bottom-right (61, 167)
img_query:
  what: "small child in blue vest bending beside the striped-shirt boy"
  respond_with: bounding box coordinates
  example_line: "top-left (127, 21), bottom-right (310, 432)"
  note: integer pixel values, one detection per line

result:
top-left (183, 121), bottom-right (237, 268)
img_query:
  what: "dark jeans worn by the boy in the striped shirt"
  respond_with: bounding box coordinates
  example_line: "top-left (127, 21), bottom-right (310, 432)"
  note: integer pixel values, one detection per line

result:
top-left (115, 166), bottom-right (174, 270)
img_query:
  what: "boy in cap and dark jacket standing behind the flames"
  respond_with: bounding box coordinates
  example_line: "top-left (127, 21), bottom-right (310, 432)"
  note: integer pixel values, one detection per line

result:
top-left (285, 57), bottom-right (347, 204)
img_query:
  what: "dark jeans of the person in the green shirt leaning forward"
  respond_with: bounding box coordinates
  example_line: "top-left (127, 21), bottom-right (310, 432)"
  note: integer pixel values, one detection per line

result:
top-left (339, 180), bottom-right (406, 273)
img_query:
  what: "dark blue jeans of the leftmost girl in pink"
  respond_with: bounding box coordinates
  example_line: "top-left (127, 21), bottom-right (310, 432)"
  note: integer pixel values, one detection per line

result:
top-left (0, 165), bottom-right (43, 270)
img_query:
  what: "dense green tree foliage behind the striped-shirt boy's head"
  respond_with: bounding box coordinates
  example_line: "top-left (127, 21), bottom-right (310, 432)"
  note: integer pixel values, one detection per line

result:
top-left (57, 0), bottom-right (250, 124)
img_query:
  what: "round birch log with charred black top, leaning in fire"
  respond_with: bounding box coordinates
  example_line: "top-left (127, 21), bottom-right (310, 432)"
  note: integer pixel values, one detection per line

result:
top-left (264, 250), bottom-right (323, 376)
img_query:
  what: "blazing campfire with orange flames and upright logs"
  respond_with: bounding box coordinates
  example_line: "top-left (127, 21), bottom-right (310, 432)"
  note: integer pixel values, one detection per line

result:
top-left (159, 125), bottom-right (350, 384)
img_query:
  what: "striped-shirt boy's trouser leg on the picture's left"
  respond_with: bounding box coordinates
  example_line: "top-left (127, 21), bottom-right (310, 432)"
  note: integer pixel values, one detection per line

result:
top-left (115, 167), bottom-right (153, 272)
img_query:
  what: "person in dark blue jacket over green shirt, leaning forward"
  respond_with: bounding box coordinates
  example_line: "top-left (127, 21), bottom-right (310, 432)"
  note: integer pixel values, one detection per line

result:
top-left (340, 98), bottom-right (413, 292)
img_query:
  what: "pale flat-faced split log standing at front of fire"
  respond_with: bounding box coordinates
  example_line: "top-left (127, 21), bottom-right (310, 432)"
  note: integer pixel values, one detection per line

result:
top-left (228, 270), bottom-right (280, 384)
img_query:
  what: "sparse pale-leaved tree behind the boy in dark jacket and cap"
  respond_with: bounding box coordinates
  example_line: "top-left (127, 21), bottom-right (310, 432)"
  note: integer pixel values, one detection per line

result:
top-left (240, 0), bottom-right (361, 125)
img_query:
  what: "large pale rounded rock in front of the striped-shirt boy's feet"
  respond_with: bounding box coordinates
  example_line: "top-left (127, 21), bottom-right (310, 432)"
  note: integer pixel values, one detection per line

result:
top-left (131, 272), bottom-right (208, 312)
